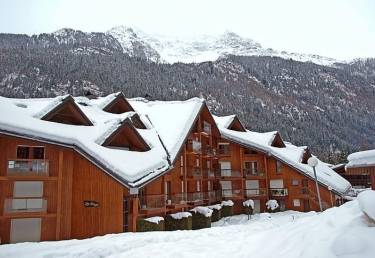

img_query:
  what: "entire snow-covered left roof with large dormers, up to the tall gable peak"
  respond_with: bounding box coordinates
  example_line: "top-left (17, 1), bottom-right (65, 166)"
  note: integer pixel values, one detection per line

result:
top-left (0, 93), bottom-right (204, 187)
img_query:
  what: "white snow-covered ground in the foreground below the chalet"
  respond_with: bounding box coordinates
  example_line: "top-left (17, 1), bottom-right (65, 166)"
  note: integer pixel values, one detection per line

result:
top-left (0, 200), bottom-right (375, 258)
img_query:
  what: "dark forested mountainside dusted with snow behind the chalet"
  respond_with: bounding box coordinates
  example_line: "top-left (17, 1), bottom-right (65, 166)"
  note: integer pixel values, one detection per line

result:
top-left (0, 26), bottom-right (375, 162)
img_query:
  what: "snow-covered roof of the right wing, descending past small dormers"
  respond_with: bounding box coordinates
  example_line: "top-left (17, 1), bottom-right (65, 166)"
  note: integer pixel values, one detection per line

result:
top-left (215, 118), bottom-right (351, 194)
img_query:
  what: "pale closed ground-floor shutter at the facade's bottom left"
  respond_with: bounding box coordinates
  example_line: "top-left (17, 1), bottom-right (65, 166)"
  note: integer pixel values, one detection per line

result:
top-left (10, 218), bottom-right (42, 243)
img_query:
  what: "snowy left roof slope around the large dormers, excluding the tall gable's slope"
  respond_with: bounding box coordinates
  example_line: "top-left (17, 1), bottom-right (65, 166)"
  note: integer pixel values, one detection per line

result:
top-left (0, 94), bottom-right (171, 187)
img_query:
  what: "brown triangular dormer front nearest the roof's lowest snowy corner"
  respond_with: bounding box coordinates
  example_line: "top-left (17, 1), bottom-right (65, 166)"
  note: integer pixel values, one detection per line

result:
top-left (103, 120), bottom-right (150, 151)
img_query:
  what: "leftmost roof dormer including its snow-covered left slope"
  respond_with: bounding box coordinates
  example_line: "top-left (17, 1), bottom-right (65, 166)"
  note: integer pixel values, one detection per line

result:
top-left (35, 95), bottom-right (93, 126)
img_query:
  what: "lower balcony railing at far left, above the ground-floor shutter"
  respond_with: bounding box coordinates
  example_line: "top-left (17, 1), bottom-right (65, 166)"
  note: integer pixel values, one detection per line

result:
top-left (4, 198), bottom-right (47, 213)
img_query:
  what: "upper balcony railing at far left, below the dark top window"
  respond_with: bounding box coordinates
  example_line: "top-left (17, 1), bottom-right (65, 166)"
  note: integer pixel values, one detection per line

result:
top-left (7, 159), bottom-right (49, 176)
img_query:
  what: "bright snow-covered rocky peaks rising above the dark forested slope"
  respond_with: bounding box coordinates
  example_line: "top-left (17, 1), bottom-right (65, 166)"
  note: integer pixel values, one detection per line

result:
top-left (107, 26), bottom-right (338, 65)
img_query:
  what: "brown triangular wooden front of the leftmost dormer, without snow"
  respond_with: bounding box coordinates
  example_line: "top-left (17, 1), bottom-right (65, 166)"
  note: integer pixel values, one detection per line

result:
top-left (41, 97), bottom-right (92, 126)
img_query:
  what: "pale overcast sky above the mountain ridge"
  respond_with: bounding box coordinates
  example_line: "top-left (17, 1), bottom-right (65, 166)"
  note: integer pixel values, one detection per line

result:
top-left (0, 0), bottom-right (375, 59)
